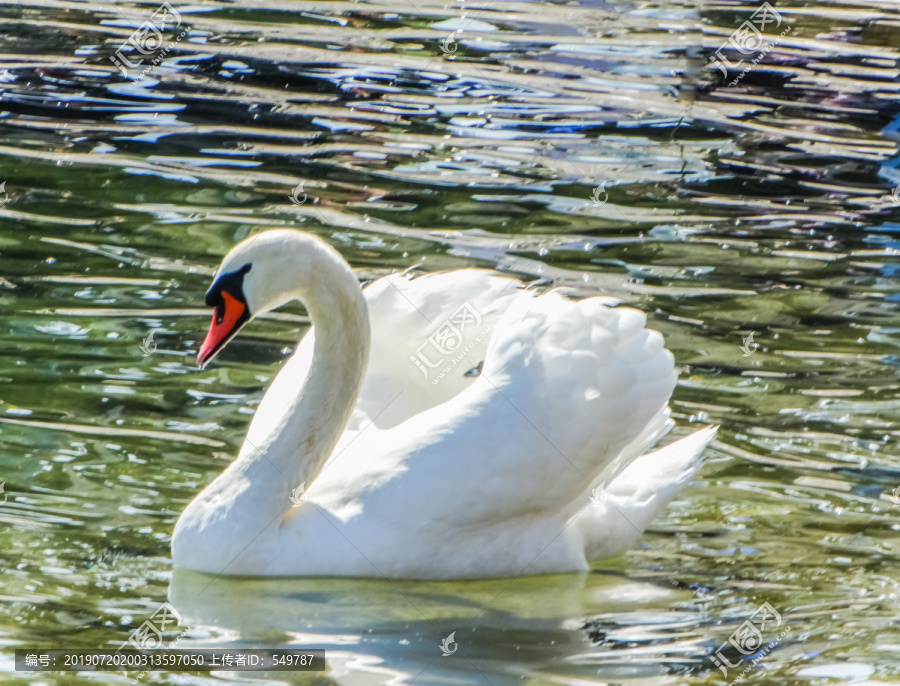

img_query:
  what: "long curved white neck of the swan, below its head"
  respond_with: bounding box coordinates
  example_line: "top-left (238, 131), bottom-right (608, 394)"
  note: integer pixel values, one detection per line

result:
top-left (234, 248), bottom-right (370, 512)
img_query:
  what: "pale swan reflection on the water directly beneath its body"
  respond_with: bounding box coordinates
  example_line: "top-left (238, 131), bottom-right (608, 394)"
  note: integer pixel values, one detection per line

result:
top-left (169, 569), bottom-right (688, 686)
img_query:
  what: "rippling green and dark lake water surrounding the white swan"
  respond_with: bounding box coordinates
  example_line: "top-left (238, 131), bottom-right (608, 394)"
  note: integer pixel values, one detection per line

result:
top-left (0, 0), bottom-right (900, 686)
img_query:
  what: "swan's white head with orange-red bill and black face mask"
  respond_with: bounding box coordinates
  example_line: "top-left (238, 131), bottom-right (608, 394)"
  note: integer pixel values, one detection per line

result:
top-left (197, 229), bottom-right (349, 367)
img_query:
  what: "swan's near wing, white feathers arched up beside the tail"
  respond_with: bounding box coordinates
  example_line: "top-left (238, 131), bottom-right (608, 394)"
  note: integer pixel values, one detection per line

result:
top-left (358, 291), bottom-right (676, 520)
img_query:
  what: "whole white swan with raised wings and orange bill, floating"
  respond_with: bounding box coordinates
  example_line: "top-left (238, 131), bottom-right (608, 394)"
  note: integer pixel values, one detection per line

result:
top-left (172, 230), bottom-right (715, 579)
